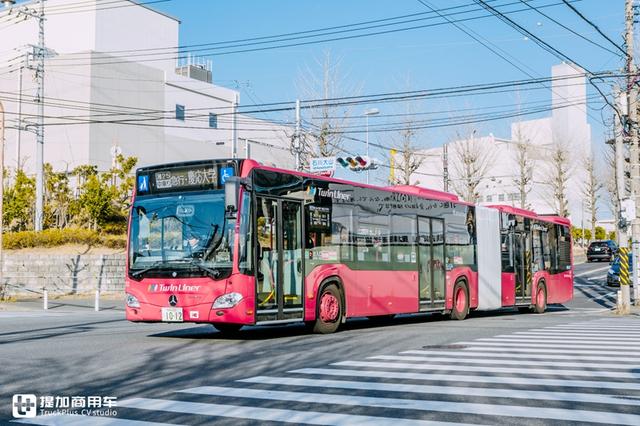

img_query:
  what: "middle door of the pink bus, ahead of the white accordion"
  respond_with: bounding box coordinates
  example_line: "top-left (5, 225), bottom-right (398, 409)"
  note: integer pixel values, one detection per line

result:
top-left (418, 217), bottom-right (446, 311)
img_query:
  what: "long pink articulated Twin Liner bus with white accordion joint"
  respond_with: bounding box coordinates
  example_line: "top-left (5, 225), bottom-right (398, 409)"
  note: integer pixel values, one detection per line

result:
top-left (126, 160), bottom-right (573, 333)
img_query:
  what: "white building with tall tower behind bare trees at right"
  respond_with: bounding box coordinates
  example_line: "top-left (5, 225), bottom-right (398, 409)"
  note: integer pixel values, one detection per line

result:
top-left (418, 63), bottom-right (591, 226)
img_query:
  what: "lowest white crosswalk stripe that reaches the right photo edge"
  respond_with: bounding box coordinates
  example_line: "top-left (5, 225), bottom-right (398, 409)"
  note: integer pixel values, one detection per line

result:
top-left (180, 386), bottom-right (640, 426)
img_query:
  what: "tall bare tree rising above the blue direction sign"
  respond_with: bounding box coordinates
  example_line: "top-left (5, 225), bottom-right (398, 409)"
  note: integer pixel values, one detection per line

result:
top-left (298, 51), bottom-right (358, 164)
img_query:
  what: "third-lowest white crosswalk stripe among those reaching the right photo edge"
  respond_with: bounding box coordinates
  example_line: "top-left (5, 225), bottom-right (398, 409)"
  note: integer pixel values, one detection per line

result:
top-left (288, 368), bottom-right (640, 391)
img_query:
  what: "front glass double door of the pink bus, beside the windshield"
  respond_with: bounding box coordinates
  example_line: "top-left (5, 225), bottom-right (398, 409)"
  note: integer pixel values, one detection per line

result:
top-left (256, 197), bottom-right (304, 323)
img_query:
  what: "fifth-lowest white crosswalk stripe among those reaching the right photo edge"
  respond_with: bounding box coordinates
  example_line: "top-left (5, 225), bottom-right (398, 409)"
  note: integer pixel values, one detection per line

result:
top-left (367, 353), bottom-right (640, 370)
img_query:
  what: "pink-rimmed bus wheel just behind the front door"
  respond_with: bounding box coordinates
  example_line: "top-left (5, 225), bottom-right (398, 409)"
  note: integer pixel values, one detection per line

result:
top-left (313, 277), bottom-right (345, 334)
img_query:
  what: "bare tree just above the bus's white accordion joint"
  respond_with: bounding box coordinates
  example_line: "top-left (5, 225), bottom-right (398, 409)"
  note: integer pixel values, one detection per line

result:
top-left (450, 130), bottom-right (493, 203)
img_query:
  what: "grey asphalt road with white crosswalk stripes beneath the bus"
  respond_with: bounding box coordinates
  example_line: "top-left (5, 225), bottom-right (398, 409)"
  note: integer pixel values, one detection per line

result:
top-left (0, 263), bottom-right (640, 426)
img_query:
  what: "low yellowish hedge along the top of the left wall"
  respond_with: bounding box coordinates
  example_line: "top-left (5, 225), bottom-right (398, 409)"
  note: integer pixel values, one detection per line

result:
top-left (2, 228), bottom-right (127, 250)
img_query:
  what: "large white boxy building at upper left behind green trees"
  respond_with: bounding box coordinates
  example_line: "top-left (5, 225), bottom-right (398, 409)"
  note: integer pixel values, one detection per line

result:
top-left (0, 0), bottom-right (293, 172)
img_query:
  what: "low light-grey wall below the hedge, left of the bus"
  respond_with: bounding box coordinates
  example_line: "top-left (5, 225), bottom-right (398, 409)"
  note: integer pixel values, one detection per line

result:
top-left (0, 253), bottom-right (125, 296)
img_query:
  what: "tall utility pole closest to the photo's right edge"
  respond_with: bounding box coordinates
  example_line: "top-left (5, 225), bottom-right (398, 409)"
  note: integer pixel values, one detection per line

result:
top-left (620, 0), bottom-right (640, 313)
